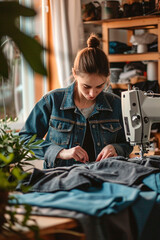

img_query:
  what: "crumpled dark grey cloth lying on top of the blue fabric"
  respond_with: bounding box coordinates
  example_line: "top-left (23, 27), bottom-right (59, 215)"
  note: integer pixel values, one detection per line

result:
top-left (17, 157), bottom-right (159, 192)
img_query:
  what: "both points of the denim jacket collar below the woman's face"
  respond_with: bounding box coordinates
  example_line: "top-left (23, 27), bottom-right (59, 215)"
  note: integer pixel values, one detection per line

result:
top-left (60, 82), bottom-right (113, 111)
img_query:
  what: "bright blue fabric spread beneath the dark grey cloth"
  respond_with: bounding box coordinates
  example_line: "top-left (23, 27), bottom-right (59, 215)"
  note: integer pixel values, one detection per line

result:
top-left (11, 182), bottom-right (140, 217)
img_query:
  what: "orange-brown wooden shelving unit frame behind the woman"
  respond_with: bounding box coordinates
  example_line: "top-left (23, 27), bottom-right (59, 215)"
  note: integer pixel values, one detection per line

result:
top-left (84, 15), bottom-right (160, 89)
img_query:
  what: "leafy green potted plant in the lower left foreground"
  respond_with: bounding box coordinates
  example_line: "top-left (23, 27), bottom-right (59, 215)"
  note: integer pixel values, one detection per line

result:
top-left (0, 119), bottom-right (42, 239)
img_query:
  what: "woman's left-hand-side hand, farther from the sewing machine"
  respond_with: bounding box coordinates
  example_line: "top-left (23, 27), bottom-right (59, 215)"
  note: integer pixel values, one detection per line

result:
top-left (57, 146), bottom-right (89, 163)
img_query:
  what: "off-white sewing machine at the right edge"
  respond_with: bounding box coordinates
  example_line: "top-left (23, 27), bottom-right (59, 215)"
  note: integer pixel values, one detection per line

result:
top-left (121, 89), bottom-right (160, 158)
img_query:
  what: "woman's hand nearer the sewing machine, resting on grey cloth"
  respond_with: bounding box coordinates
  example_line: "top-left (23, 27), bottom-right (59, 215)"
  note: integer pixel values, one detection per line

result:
top-left (96, 145), bottom-right (117, 162)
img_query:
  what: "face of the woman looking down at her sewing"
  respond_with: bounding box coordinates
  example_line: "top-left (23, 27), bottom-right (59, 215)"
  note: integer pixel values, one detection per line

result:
top-left (74, 73), bottom-right (108, 101)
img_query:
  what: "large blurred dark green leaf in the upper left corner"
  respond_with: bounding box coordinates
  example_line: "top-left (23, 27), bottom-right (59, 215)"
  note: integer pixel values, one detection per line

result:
top-left (0, 1), bottom-right (47, 78)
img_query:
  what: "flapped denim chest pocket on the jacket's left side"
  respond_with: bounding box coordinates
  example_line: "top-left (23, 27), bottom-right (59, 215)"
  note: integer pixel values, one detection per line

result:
top-left (50, 119), bottom-right (74, 147)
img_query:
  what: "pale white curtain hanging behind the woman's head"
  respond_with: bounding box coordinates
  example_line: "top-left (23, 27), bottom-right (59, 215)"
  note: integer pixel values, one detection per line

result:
top-left (50, 0), bottom-right (84, 87)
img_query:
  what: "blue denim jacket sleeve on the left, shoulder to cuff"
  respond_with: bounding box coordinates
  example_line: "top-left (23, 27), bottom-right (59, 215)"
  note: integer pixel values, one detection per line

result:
top-left (19, 94), bottom-right (63, 167)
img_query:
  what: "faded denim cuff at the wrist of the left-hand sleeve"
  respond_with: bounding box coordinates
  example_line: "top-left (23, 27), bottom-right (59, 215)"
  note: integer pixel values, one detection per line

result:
top-left (44, 145), bottom-right (64, 168)
